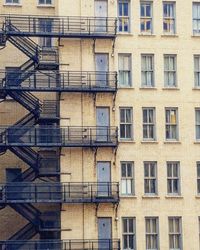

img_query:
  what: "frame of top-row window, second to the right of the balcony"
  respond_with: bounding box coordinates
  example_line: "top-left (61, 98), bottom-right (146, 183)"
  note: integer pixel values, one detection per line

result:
top-left (140, 0), bottom-right (153, 35)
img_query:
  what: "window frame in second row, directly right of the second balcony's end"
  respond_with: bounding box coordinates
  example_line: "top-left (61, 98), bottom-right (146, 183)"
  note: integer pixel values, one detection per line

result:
top-left (118, 53), bottom-right (132, 88)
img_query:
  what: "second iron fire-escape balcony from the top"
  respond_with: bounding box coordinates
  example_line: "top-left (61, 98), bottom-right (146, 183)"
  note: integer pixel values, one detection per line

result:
top-left (0, 70), bottom-right (117, 92)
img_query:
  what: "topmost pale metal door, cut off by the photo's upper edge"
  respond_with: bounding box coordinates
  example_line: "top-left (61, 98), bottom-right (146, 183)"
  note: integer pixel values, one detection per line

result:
top-left (94, 0), bottom-right (108, 32)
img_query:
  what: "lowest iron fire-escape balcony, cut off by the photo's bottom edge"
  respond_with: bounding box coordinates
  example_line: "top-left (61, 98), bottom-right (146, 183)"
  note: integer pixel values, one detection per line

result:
top-left (0, 239), bottom-right (120, 250)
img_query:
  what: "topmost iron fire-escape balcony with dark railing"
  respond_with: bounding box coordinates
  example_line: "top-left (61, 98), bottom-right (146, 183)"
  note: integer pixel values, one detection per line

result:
top-left (0, 15), bottom-right (117, 39)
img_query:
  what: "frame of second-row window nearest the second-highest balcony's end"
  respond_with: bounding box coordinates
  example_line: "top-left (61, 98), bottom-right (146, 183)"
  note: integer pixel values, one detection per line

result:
top-left (118, 54), bottom-right (132, 88)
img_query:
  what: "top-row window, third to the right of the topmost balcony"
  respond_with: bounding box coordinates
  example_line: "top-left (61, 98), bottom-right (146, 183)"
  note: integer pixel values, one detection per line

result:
top-left (163, 2), bottom-right (176, 34)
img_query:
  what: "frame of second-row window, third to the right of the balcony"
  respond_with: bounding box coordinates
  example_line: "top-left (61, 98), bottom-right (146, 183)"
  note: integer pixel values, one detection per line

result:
top-left (164, 54), bottom-right (178, 88)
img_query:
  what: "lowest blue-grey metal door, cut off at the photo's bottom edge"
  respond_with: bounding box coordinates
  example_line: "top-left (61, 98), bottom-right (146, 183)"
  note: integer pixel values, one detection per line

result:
top-left (98, 218), bottom-right (112, 250)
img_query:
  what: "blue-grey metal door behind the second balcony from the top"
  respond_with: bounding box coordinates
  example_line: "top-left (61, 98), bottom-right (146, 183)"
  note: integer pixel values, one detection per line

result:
top-left (95, 54), bottom-right (109, 87)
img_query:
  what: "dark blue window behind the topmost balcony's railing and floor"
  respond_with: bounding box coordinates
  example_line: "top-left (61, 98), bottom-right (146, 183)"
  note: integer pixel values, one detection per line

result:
top-left (39, 19), bottom-right (53, 47)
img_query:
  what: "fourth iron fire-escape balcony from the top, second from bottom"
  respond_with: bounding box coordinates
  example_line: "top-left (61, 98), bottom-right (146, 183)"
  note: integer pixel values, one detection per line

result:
top-left (0, 182), bottom-right (119, 204)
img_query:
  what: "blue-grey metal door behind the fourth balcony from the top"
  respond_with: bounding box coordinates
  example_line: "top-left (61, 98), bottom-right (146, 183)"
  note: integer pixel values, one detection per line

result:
top-left (97, 162), bottom-right (111, 197)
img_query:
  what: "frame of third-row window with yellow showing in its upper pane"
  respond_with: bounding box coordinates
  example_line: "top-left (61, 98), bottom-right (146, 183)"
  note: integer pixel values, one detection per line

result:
top-left (165, 107), bottom-right (179, 141)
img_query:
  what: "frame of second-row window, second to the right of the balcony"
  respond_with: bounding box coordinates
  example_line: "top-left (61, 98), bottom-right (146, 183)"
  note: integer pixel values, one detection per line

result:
top-left (141, 54), bottom-right (155, 88)
